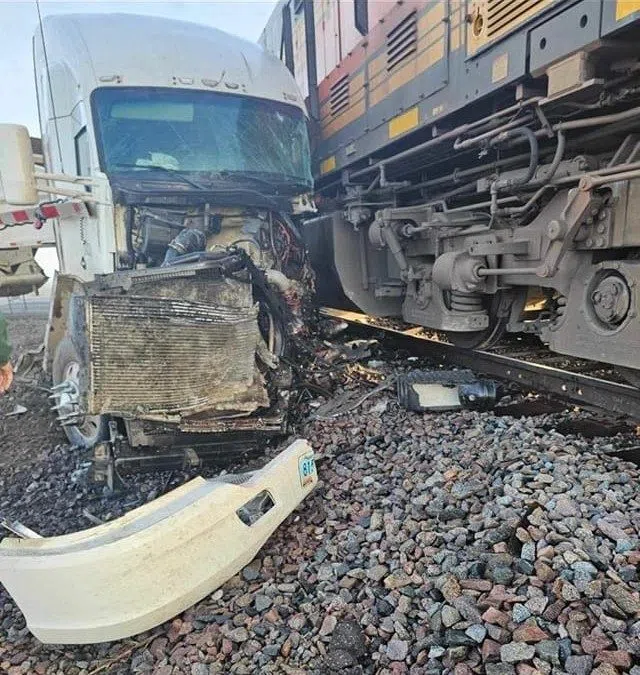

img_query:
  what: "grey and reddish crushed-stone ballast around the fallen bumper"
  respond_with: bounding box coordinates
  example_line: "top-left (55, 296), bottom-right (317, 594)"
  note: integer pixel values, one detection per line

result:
top-left (0, 318), bottom-right (640, 675)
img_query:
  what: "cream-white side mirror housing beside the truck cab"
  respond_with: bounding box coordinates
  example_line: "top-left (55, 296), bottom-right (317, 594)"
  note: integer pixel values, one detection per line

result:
top-left (0, 124), bottom-right (38, 206)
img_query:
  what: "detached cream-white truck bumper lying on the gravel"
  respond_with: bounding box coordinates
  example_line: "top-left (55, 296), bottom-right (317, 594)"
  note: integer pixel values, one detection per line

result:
top-left (0, 440), bottom-right (317, 644)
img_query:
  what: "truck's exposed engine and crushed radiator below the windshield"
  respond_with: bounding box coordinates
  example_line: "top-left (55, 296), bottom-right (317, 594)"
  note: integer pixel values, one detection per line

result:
top-left (54, 204), bottom-right (314, 480)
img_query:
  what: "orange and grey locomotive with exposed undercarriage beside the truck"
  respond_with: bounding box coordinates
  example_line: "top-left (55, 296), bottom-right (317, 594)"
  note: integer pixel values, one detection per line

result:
top-left (261, 0), bottom-right (640, 379)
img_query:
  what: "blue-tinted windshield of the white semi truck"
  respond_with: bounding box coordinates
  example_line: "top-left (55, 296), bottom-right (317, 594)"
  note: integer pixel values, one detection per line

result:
top-left (92, 87), bottom-right (312, 187)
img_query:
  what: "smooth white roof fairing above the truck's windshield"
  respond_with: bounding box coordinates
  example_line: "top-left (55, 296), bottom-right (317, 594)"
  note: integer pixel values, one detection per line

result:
top-left (34, 14), bottom-right (305, 110)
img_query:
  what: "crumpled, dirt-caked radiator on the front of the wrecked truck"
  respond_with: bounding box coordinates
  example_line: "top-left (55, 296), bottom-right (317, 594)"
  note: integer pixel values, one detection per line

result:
top-left (88, 295), bottom-right (258, 417)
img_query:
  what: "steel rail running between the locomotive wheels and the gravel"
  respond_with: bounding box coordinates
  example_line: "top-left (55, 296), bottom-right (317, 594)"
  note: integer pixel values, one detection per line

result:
top-left (320, 307), bottom-right (640, 420)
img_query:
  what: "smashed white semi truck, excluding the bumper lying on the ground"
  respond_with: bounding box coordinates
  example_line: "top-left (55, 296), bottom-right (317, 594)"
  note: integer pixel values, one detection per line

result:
top-left (0, 14), bottom-right (314, 476)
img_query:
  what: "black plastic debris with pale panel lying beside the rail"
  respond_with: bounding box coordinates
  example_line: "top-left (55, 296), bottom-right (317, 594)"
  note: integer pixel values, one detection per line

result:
top-left (397, 370), bottom-right (497, 412)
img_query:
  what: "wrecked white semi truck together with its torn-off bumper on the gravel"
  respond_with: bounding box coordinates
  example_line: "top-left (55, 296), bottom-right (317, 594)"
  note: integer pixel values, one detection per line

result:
top-left (0, 15), bottom-right (317, 643)
